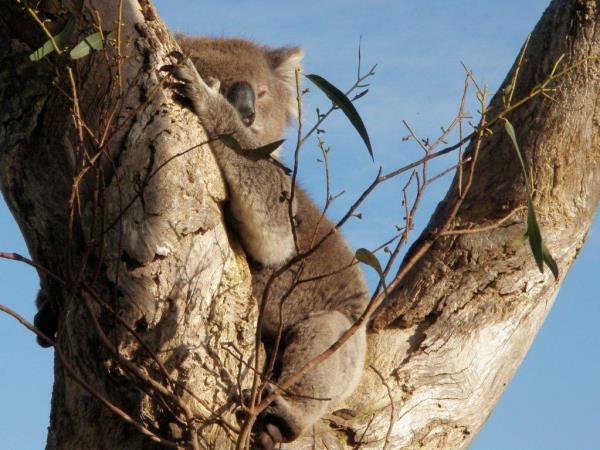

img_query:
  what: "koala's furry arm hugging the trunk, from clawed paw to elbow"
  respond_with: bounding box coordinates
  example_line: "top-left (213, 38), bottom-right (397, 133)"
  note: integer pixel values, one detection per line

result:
top-left (174, 60), bottom-right (295, 266)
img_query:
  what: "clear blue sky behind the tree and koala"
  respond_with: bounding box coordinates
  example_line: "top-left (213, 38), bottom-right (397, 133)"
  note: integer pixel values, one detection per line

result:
top-left (0, 0), bottom-right (600, 450)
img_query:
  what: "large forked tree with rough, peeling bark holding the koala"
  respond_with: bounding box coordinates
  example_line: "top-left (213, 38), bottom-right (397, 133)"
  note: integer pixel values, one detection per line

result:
top-left (0, 1), bottom-right (599, 448)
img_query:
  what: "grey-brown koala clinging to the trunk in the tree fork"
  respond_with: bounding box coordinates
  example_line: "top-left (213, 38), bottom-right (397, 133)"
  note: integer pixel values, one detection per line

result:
top-left (173, 35), bottom-right (368, 450)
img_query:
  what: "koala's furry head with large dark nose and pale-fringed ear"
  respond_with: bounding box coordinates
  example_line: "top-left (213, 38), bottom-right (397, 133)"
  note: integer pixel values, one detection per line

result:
top-left (177, 35), bottom-right (304, 144)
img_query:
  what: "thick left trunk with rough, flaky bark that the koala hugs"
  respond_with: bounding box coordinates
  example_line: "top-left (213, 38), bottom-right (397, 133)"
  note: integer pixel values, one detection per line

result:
top-left (0, 1), bottom-right (255, 449)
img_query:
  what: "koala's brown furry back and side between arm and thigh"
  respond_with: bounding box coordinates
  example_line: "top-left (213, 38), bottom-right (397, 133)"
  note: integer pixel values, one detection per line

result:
top-left (252, 188), bottom-right (369, 338)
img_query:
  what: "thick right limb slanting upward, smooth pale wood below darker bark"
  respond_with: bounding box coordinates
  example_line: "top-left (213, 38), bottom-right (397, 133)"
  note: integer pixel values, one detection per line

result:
top-left (338, 0), bottom-right (600, 449)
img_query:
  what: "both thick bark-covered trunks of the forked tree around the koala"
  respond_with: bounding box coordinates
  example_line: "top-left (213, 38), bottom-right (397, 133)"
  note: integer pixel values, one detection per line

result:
top-left (0, 0), bottom-right (600, 449)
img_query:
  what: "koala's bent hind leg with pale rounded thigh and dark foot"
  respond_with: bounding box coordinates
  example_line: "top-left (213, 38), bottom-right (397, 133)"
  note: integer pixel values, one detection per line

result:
top-left (257, 311), bottom-right (367, 450)
